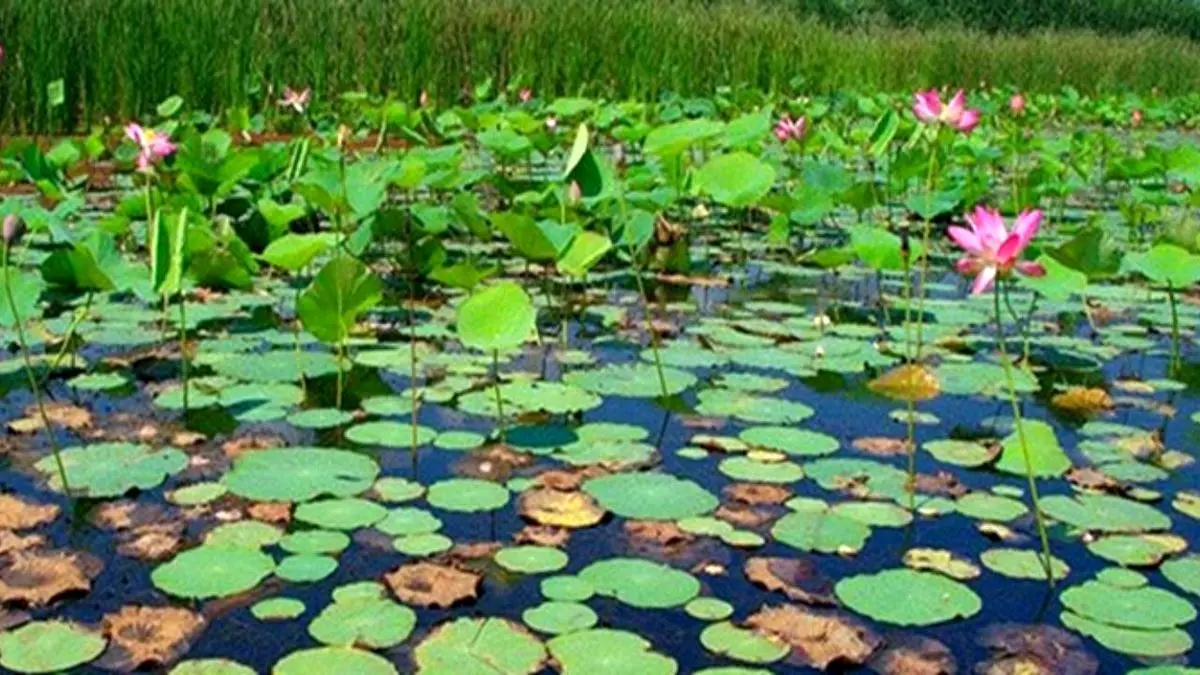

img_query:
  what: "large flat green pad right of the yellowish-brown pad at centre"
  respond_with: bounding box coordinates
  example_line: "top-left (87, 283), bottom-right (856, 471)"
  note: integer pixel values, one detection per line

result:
top-left (583, 472), bottom-right (720, 520)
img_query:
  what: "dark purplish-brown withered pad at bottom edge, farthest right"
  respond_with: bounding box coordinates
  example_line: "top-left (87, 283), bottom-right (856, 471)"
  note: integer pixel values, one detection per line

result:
top-left (974, 623), bottom-right (1099, 675)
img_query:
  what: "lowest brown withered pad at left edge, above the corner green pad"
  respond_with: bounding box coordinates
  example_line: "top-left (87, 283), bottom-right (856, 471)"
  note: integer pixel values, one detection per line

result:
top-left (0, 550), bottom-right (102, 607)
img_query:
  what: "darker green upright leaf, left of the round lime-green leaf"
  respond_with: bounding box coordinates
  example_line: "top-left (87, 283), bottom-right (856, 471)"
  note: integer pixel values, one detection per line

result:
top-left (296, 255), bottom-right (383, 345)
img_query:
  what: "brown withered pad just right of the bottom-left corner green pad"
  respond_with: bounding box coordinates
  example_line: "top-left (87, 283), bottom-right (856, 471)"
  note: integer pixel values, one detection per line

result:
top-left (96, 605), bottom-right (204, 673)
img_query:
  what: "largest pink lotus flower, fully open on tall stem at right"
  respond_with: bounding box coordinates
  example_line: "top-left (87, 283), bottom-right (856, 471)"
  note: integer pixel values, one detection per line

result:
top-left (949, 207), bottom-right (1046, 295)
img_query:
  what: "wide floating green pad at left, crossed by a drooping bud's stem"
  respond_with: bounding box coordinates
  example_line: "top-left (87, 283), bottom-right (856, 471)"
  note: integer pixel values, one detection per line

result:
top-left (34, 443), bottom-right (187, 497)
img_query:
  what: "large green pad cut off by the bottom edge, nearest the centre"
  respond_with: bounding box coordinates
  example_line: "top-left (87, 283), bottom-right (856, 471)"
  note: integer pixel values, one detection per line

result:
top-left (547, 628), bottom-right (679, 675)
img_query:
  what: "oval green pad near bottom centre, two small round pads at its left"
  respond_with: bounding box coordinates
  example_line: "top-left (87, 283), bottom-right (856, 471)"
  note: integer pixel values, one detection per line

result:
top-left (580, 557), bottom-right (700, 609)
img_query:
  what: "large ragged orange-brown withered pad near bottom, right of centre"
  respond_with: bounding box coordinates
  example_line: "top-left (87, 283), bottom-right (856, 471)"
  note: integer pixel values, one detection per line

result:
top-left (745, 604), bottom-right (882, 670)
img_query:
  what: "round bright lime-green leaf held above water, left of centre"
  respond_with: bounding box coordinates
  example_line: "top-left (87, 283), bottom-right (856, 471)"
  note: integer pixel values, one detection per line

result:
top-left (457, 281), bottom-right (536, 352)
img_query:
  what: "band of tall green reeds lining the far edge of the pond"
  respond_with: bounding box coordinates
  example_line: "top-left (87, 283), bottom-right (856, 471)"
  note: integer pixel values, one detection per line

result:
top-left (0, 0), bottom-right (1200, 133)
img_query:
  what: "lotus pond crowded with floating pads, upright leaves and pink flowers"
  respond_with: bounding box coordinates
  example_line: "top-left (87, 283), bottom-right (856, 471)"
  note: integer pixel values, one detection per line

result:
top-left (0, 89), bottom-right (1200, 675)
